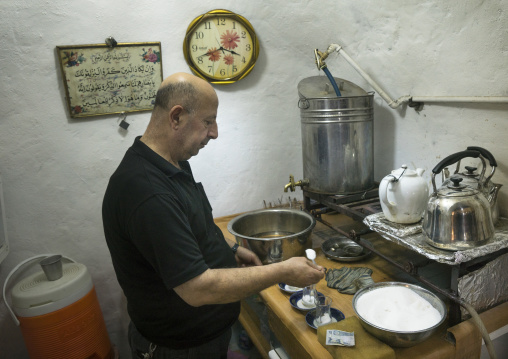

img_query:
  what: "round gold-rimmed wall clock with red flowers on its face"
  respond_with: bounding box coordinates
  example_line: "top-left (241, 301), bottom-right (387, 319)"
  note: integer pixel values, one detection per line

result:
top-left (183, 10), bottom-right (259, 84)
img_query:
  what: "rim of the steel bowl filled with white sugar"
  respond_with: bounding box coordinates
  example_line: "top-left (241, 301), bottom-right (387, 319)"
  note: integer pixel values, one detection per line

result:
top-left (352, 282), bottom-right (448, 335)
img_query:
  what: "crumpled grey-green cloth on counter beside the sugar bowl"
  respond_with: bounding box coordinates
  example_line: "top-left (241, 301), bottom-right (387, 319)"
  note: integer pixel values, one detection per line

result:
top-left (326, 267), bottom-right (374, 294)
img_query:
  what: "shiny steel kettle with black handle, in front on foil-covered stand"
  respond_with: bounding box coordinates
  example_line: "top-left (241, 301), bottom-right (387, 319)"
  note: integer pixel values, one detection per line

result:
top-left (422, 150), bottom-right (494, 251)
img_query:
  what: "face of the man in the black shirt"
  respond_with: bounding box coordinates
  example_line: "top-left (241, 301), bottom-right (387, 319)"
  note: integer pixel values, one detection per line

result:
top-left (182, 101), bottom-right (219, 160)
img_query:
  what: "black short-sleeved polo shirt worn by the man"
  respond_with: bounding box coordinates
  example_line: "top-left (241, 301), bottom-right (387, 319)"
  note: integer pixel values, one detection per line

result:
top-left (102, 137), bottom-right (240, 349)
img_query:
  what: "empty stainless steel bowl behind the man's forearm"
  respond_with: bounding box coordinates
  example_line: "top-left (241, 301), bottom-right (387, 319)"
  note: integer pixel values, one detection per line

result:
top-left (228, 208), bottom-right (316, 264)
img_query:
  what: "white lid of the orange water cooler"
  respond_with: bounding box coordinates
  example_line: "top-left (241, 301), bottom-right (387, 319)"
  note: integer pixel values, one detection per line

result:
top-left (11, 263), bottom-right (93, 317)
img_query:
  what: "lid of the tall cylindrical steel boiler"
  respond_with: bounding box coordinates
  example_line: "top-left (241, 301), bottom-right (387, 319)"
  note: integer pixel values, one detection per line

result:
top-left (298, 76), bottom-right (367, 98)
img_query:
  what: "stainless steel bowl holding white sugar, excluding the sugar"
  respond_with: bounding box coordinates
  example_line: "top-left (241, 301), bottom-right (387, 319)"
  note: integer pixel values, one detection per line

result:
top-left (353, 282), bottom-right (447, 347)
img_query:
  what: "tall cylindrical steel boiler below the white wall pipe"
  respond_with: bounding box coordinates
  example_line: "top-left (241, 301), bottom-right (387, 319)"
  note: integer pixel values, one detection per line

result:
top-left (298, 76), bottom-right (374, 194)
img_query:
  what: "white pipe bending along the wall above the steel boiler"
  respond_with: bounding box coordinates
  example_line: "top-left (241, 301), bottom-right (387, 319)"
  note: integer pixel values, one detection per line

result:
top-left (325, 44), bottom-right (508, 108)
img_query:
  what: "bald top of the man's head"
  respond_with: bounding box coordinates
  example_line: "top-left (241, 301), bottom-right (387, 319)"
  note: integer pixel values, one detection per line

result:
top-left (154, 72), bottom-right (217, 113)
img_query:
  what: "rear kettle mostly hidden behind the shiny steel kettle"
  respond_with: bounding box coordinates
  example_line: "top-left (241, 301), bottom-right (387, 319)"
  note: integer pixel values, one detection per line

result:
top-left (442, 146), bottom-right (503, 225)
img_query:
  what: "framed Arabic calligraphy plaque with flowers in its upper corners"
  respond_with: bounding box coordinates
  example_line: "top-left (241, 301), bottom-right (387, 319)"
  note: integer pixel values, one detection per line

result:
top-left (56, 42), bottom-right (162, 118)
